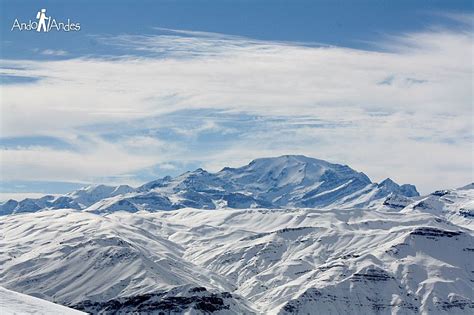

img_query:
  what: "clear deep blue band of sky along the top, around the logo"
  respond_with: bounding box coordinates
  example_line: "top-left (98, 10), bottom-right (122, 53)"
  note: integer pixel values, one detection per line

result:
top-left (1, 0), bottom-right (473, 58)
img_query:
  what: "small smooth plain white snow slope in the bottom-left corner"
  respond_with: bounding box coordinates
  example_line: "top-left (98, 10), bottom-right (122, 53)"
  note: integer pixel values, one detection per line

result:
top-left (0, 287), bottom-right (85, 315)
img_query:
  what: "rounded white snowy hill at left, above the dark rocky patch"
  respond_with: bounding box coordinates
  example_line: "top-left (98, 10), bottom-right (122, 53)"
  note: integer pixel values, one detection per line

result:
top-left (0, 210), bottom-right (258, 313)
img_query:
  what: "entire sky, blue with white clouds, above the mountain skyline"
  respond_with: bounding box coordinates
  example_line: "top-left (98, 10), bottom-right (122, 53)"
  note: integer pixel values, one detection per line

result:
top-left (0, 0), bottom-right (474, 199)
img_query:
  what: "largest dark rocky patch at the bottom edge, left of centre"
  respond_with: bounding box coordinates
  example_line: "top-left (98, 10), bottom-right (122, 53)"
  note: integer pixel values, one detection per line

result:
top-left (70, 287), bottom-right (233, 314)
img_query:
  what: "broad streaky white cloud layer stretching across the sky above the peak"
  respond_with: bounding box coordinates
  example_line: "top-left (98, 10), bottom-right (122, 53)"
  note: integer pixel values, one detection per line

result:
top-left (1, 22), bottom-right (473, 192)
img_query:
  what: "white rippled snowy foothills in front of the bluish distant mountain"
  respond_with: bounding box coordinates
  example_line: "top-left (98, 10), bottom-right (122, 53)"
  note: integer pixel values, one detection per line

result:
top-left (0, 197), bottom-right (474, 314)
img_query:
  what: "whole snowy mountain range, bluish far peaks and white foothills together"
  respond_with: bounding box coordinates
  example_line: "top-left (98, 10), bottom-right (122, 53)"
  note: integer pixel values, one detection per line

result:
top-left (0, 156), bottom-right (474, 314)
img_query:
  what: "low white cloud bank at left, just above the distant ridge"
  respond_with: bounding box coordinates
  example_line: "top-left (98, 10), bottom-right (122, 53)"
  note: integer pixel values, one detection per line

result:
top-left (0, 135), bottom-right (179, 183)
